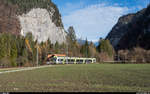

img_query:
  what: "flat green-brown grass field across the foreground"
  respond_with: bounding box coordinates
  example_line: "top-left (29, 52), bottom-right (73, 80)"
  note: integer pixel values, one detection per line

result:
top-left (0, 64), bottom-right (150, 92)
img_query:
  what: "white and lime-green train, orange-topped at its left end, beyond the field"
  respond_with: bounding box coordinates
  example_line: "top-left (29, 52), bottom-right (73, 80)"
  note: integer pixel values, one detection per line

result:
top-left (47, 54), bottom-right (96, 65)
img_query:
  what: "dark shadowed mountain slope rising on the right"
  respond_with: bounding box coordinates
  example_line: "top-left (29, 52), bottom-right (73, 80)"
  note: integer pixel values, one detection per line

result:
top-left (106, 5), bottom-right (150, 50)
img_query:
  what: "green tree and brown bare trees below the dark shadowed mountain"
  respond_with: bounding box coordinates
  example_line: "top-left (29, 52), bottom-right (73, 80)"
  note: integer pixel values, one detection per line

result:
top-left (97, 39), bottom-right (150, 63)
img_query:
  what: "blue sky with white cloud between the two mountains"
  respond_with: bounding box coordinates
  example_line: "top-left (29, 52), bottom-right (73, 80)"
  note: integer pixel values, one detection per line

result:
top-left (52, 0), bottom-right (150, 42)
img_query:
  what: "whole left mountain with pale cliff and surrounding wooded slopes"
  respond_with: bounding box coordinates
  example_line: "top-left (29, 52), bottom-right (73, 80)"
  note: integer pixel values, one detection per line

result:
top-left (0, 0), bottom-right (66, 43)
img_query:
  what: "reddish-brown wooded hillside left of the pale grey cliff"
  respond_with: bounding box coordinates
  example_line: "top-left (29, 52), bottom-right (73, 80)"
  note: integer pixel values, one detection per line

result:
top-left (0, 0), bottom-right (21, 34)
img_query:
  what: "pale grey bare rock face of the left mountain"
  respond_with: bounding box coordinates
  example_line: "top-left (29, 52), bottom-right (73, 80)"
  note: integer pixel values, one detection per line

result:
top-left (18, 8), bottom-right (66, 43)
